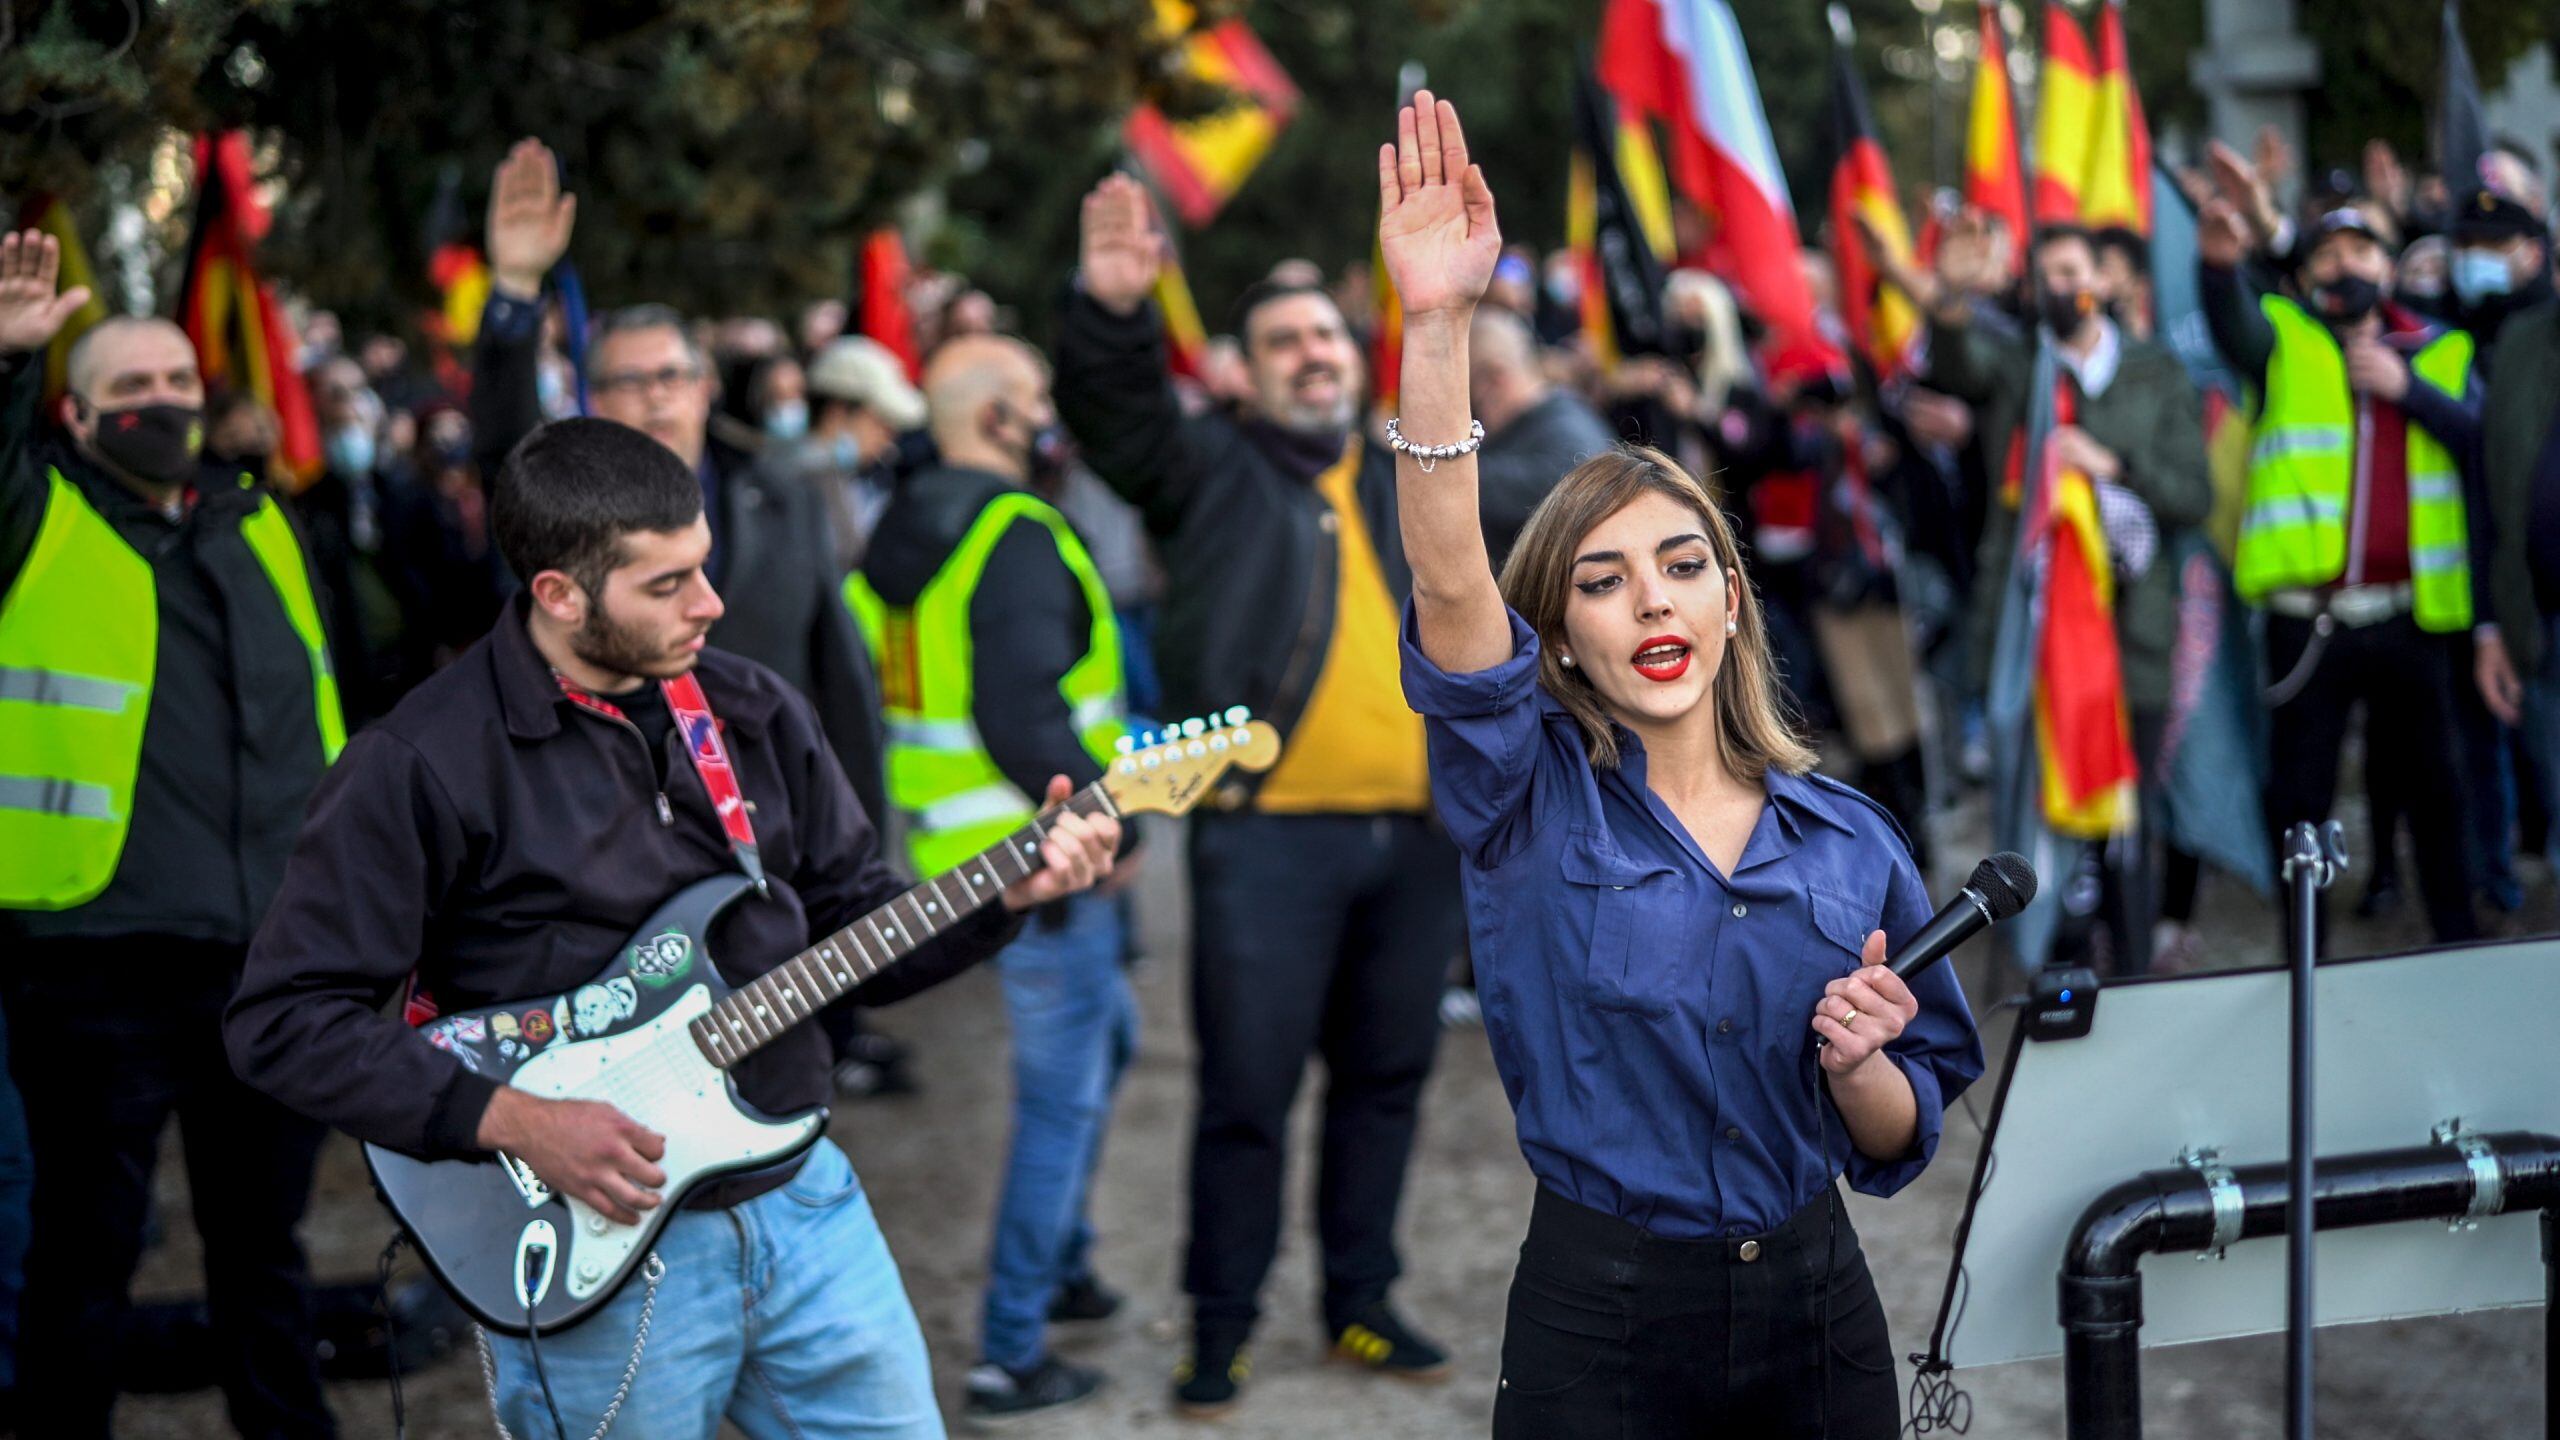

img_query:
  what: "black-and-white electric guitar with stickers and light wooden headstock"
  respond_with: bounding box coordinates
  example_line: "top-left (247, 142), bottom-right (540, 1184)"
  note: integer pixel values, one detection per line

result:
top-left (364, 710), bottom-right (1280, 1335)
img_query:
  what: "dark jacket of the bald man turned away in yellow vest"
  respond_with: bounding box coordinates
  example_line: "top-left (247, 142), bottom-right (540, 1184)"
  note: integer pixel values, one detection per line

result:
top-left (863, 466), bottom-right (1105, 789)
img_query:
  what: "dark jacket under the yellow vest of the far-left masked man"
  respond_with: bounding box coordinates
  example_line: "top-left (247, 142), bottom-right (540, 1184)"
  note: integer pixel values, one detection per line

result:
top-left (0, 356), bottom-right (330, 945)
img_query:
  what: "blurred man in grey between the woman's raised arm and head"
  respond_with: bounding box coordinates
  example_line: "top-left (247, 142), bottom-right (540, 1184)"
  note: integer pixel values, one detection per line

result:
top-left (1467, 305), bottom-right (1610, 571)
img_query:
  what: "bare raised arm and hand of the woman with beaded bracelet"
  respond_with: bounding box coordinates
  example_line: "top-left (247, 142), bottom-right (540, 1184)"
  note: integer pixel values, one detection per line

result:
top-left (1377, 90), bottom-right (1510, 674)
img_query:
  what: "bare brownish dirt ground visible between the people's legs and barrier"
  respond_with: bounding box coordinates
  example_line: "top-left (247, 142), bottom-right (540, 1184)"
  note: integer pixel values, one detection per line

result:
top-left (118, 784), bottom-right (2560, 1440)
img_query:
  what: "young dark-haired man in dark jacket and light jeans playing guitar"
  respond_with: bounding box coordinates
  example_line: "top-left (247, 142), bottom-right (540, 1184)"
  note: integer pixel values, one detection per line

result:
top-left (225, 420), bottom-right (1119, 1437)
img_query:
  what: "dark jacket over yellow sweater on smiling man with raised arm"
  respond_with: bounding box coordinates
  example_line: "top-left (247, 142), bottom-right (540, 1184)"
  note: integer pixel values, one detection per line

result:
top-left (1057, 292), bottom-right (1413, 768)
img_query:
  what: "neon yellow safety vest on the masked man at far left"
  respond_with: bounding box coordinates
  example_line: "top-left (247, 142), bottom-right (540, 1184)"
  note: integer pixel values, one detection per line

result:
top-left (0, 471), bottom-right (346, 910)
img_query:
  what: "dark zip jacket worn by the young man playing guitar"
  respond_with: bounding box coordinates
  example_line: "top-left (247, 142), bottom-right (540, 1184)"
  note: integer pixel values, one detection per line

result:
top-left (223, 600), bottom-right (1019, 1156)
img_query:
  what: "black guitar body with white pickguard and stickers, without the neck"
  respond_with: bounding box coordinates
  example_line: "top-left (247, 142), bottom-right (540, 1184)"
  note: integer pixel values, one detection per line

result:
top-left (364, 874), bottom-right (827, 1335)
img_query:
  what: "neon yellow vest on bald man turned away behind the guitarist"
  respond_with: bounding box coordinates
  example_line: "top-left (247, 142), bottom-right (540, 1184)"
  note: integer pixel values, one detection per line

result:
top-left (845, 492), bottom-right (1126, 874)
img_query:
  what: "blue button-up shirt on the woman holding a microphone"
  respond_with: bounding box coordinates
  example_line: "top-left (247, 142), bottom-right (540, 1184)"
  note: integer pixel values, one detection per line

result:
top-left (1403, 610), bottom-right (1981, 1240)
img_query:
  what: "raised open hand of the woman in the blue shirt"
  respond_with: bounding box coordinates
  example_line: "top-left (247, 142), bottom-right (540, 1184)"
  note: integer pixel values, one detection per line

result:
top-left (1377, 90), bottom-right (1503, 315)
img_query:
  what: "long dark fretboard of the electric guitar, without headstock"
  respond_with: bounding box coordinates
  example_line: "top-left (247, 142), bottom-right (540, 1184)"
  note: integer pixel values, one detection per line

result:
top-left (691, 784), bottom-right (1119, 1068)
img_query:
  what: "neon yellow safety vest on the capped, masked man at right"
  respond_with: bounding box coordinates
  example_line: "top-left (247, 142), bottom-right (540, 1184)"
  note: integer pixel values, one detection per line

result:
top-left (2232, 295), bottom-right (2470, 633)
